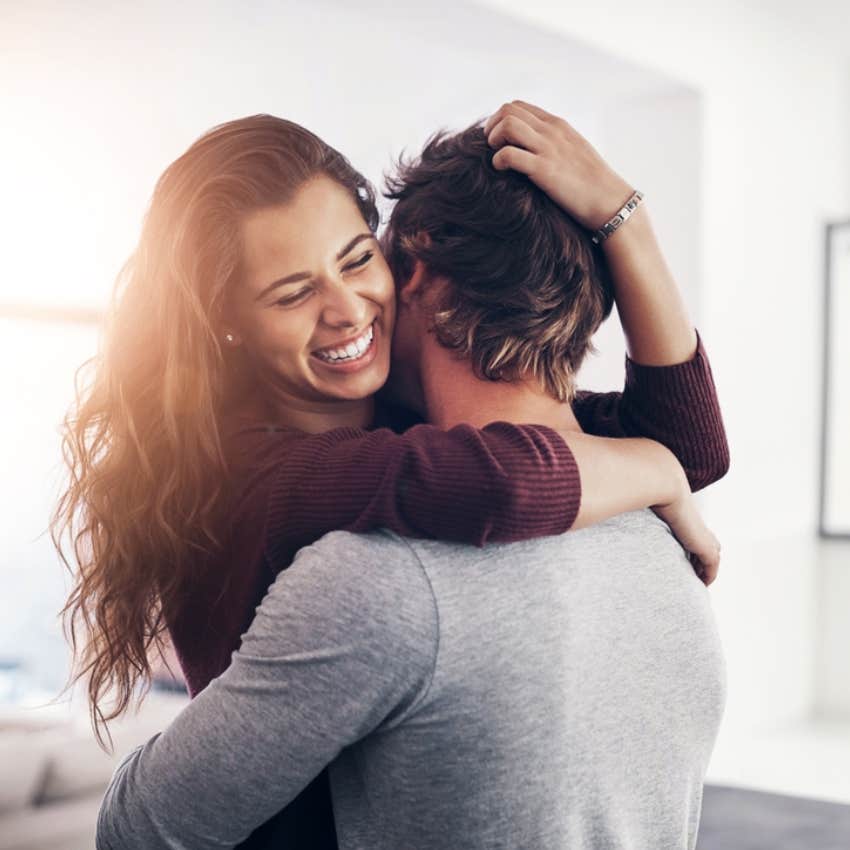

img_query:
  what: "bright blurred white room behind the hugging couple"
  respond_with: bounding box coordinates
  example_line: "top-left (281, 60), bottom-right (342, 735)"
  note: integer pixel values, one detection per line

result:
top-left (0, 0), bottom-right (850, 850)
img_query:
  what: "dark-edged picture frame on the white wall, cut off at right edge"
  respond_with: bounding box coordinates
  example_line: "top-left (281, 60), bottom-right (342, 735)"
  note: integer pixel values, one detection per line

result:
top-left (819, 221), bottom-right (850, 540)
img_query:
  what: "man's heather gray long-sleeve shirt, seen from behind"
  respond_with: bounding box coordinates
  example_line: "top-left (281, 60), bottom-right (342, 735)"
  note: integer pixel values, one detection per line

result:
top-left (98, 511), bottom-right (725, 850)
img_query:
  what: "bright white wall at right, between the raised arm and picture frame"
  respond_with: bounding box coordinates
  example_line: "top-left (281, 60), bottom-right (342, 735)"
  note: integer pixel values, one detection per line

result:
top-left (480, 0), bottom-right (850, 728)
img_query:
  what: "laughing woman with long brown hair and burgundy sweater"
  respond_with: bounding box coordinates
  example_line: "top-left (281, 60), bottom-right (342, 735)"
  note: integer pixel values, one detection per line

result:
top-left (55, 106), bottom-right (725, 847)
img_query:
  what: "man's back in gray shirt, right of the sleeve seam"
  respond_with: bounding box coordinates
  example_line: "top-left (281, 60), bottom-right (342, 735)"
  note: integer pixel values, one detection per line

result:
top-left (330, 511), bottom-right (725, 850)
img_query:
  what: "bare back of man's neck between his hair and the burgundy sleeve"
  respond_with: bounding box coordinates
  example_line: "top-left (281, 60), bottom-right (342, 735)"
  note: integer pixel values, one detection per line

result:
top-left (421, 334), bottom-right (581, 432)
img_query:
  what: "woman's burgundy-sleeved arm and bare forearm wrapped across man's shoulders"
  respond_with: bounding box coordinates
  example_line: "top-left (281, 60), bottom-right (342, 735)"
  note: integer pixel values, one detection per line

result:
top-left (262, 422), bottom-right (686, 564)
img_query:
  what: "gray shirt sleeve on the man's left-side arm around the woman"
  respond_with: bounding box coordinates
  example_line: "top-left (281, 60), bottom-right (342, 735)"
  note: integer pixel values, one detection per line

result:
top-left (97, 532), bottom-right (438, 850)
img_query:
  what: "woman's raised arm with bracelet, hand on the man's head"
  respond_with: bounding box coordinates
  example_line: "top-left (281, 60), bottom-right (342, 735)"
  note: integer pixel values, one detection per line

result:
top-left (484, 101), bottom-right (729, 490)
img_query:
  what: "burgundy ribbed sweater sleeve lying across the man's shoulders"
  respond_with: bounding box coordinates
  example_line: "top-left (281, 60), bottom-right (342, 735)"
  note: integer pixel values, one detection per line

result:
top-left (266, 422), bottom-right (581, 563)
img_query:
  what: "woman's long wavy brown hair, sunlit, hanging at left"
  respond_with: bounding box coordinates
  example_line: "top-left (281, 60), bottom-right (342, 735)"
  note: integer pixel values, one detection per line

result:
top-left (51, 115), bottom-right (378, 746)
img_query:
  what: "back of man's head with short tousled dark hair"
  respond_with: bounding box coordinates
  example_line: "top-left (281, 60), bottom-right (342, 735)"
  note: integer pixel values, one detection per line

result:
top-left (384, 125), bottom-right (613, 401)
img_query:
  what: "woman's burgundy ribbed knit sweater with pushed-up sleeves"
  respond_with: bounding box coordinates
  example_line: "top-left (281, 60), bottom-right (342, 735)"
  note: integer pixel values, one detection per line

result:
top-left (169, 330), bottom-right (729, 850)
